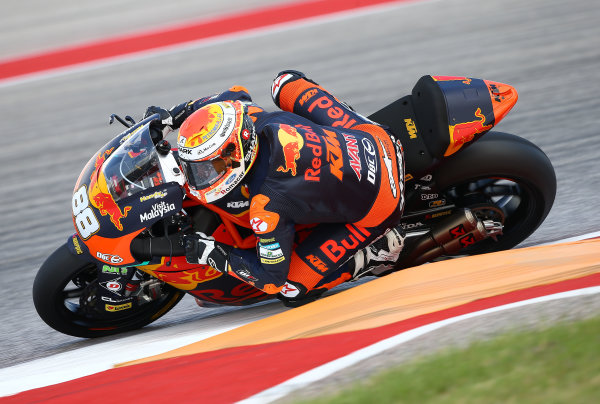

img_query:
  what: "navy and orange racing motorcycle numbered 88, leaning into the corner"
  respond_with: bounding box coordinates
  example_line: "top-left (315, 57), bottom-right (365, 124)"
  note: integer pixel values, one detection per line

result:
top-left (33, 76), bottom-right (556, 338)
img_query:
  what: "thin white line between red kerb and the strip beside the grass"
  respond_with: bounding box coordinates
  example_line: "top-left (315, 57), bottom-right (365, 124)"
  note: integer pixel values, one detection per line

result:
top-left (237, 286), bottom-right (600, 404)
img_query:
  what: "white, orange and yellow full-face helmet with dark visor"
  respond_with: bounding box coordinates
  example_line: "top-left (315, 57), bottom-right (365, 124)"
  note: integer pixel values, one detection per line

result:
top-left (177, 101), bottom-right (258, 203)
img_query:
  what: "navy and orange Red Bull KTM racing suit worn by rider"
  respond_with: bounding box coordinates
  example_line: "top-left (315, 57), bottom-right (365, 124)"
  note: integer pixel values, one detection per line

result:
top-left (159, 71), bottom-right (404, 299)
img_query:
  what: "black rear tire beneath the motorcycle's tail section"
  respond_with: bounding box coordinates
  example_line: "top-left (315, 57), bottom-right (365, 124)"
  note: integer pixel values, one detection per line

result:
top-left (434, 132), bottom-right (556, 254)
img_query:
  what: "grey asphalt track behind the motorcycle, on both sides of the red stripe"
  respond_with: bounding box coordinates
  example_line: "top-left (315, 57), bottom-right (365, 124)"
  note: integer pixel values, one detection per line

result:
top-left (0, 0), bottom-right (600, 396)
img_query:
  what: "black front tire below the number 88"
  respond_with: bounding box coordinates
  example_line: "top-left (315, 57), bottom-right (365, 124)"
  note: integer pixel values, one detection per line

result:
top-left (33, 244), bottom-right (184, 338)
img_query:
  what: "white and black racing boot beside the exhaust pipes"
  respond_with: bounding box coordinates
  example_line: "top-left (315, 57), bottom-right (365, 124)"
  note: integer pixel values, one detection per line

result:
top-left (348, 228), bottom-right (405, 281)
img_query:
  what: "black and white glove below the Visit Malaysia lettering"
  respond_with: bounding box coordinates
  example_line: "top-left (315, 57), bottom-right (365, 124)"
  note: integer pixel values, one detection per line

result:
top-left (183, 232), bottom-right (229, 272)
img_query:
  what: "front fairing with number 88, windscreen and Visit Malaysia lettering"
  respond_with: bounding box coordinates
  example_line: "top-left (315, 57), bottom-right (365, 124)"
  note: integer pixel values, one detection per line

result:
top-left (72, 120), bottom-right (185, 266)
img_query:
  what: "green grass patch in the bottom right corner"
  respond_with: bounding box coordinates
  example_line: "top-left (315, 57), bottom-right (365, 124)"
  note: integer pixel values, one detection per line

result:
top-left (296, 317), bottom-right (600, 404)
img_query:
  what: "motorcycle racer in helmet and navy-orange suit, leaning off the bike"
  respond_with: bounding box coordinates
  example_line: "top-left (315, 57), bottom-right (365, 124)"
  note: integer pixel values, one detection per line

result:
top-left (145, 70), bottom-right (404, 306)
